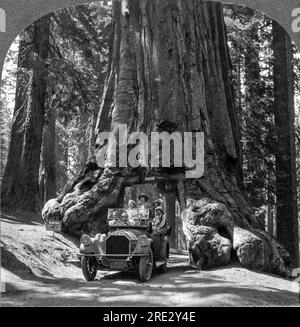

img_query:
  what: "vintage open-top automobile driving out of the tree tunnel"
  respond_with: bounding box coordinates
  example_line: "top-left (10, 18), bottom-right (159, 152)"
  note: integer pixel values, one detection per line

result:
top-left (79, 209), bottom-right (171, 282)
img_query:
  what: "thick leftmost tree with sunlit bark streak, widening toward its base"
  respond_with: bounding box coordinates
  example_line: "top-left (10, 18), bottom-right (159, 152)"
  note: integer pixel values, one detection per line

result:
top-left (1, 15), bottom-right (50, 211)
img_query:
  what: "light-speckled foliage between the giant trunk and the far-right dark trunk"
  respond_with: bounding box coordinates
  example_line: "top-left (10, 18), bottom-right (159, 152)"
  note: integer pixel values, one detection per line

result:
top-left (225, 6), bottom-right (275, 208)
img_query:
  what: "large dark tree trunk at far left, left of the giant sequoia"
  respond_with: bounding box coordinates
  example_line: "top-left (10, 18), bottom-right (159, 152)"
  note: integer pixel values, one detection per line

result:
top-left (3, 16), bottom-right (50, 211)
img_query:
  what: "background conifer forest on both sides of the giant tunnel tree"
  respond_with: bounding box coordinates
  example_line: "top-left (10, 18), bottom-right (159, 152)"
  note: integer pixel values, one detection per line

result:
top-left (0, 1), bottom-right (300, 254)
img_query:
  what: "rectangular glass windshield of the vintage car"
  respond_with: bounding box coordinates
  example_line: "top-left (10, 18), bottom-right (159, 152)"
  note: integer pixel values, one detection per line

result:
top-left (107, 208), bottom-right (149, 227)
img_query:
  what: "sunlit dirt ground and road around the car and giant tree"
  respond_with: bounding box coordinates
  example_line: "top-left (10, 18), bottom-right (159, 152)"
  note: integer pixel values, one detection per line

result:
top-left (0, 212), bottom-right (299, 306)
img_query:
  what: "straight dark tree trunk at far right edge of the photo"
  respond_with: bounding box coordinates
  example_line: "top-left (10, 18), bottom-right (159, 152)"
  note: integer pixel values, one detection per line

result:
top-left (273, 21), bottom-right (299, 267)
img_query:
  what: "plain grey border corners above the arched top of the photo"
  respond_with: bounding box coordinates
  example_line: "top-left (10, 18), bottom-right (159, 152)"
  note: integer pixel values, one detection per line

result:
top-left (0, 0), bottom-right (300, 83)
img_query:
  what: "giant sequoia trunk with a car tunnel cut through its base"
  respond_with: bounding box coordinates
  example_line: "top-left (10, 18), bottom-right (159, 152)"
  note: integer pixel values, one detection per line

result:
top-left (43, 0), bottom-right (285, 272)
